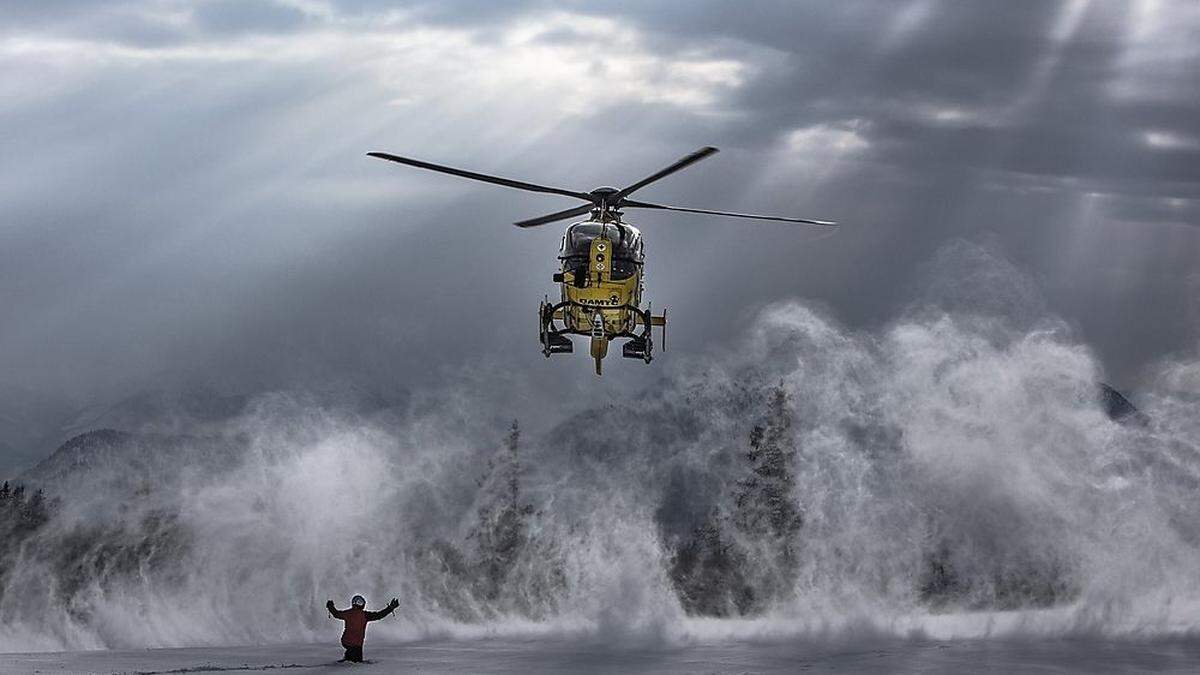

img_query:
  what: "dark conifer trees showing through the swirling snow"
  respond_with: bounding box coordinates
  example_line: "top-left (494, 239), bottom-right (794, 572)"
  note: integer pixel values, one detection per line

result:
top-left (0, 383), bottom-right (1078, 621)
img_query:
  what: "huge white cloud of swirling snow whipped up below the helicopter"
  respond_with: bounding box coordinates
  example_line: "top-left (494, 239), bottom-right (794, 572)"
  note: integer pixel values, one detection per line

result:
top-left (0, 240), bottom-right (1200, 651)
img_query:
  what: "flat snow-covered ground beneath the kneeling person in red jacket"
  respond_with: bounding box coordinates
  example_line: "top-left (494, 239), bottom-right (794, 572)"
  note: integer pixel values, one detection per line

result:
top-left (0, 639), bottom-right (1200, 675)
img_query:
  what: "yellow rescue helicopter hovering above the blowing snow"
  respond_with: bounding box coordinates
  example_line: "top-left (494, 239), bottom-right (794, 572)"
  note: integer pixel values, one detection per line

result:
top-left (367, 147), bottom-right (838, 376)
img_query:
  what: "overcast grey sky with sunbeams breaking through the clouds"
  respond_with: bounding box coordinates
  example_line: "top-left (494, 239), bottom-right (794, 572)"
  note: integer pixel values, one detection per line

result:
top-left (0, 0), bottom-right (1200, 437)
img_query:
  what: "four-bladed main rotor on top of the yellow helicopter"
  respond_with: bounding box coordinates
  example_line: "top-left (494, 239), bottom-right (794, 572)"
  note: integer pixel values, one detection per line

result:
top-left (367, 145), bottom-right (838, 227)
